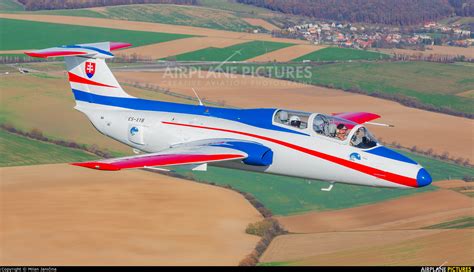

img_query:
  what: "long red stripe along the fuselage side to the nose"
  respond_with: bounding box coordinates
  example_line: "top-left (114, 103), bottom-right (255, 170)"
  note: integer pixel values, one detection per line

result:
top-left (163, 122), bottom-right (418, 187)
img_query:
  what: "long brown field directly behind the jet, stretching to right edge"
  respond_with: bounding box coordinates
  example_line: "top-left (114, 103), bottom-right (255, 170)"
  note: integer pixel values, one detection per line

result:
top-left (115, 71), bottom-right (474, 161)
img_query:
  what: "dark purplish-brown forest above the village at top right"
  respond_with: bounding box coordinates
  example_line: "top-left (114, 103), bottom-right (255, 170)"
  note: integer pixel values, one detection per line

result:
top-left (237, 0), bottom-right (474, 26)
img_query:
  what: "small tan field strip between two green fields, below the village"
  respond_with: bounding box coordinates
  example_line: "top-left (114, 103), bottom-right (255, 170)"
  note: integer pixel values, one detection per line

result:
top-left (247, 44), bottom-right (325, 62)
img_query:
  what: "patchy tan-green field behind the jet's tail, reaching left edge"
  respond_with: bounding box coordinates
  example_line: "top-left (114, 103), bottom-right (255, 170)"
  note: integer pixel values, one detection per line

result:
top-left (0, 69), bottom-right (193, 155)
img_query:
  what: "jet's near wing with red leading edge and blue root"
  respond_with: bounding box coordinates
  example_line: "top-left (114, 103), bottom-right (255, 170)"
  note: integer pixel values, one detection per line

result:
top-left (72, 139), bottom-right (273, 171)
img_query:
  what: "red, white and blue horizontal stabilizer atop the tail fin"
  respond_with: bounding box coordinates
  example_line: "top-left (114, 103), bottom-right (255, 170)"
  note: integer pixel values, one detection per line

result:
top-left (25, 42), bottom-right (131, 59)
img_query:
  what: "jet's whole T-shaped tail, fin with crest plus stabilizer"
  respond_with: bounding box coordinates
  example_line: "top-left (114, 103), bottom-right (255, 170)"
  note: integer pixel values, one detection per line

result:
top-left (25, 42), bottom-right (132, 103)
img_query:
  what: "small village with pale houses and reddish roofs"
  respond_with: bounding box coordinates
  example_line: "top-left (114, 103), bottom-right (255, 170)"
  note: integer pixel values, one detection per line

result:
top-left (273, 21), bottom-right (474, 49)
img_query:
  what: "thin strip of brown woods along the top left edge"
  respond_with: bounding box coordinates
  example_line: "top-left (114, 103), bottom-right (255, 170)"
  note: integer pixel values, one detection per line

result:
top-left (18, 0), bottom-right (197, 10)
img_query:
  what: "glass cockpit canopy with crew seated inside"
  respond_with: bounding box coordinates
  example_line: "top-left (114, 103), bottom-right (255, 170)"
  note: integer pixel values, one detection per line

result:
top-left (273, 110), bottom-right (377, 149)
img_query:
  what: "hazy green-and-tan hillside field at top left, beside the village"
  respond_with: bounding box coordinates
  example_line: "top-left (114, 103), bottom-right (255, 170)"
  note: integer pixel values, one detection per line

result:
top-left (4, 0), bottom-right (285, 32)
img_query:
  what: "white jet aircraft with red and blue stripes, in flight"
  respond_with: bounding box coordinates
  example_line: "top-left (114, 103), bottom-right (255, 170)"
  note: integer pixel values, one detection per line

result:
top-left (25, 42), bottom-right (432, 190)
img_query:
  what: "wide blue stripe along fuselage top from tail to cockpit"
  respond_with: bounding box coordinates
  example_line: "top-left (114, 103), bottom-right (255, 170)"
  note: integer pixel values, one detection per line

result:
top-left (72, 89), bottom-right (309, 136)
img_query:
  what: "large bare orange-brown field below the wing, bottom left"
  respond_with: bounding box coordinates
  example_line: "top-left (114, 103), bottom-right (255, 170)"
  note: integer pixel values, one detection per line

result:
top-left (0, 164), bottom-right (261, 266)
